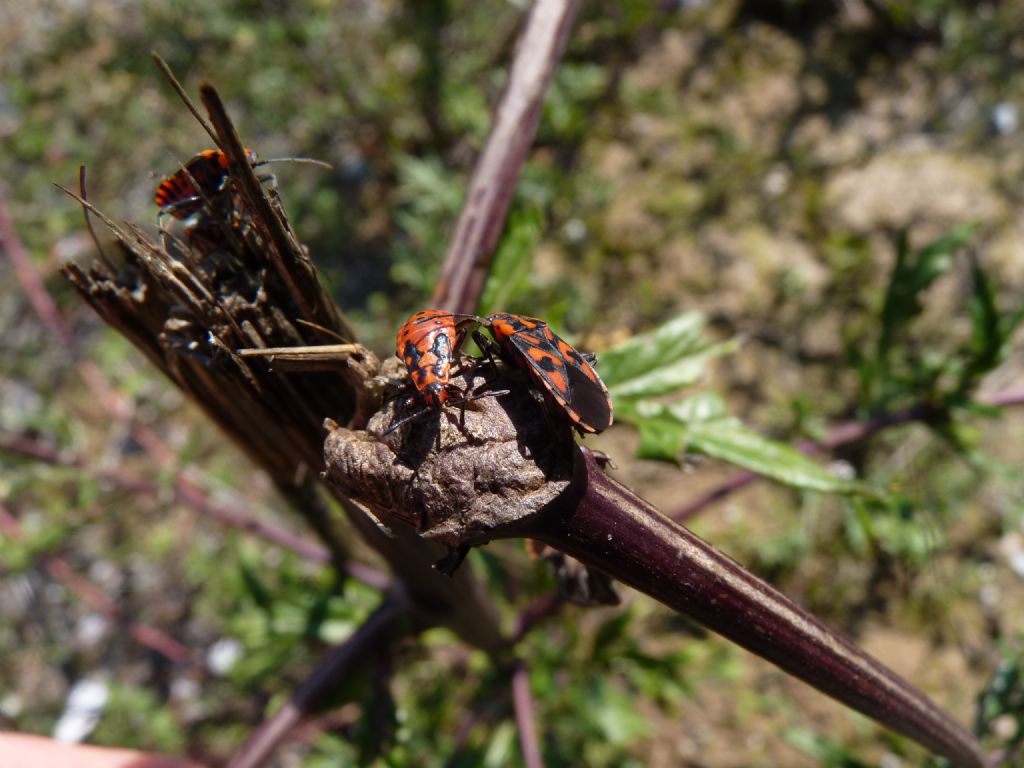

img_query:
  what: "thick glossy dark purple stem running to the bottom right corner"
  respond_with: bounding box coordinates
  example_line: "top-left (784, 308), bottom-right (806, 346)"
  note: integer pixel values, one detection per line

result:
top-left (528, 450), bottom-right (985, 768)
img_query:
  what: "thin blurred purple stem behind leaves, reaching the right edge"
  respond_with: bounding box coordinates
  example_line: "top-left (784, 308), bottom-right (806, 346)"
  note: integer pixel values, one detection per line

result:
top-left (669, 389), bottom-right (1024, 522)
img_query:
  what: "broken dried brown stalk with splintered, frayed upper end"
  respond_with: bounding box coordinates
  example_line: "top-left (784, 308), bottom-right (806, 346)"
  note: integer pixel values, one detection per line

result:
top-left (63, 76), bottom-right (504, 650)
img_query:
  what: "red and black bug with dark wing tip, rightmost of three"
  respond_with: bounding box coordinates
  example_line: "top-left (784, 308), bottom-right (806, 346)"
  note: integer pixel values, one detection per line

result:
top-left (483, 312), bottom-right (611, 433)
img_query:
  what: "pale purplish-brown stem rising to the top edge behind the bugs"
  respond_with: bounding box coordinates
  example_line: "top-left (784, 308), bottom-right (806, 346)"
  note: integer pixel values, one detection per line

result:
top-left (433, 0), bottom-right (580, 312)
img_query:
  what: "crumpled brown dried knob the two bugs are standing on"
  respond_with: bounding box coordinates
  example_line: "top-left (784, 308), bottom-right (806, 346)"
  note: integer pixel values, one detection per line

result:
top-left (325, 367), bottom-right (575, 547)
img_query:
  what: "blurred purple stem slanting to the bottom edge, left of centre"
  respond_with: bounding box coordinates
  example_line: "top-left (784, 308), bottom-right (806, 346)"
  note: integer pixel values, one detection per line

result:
top-left (227, 597), bottom-right (415, 768)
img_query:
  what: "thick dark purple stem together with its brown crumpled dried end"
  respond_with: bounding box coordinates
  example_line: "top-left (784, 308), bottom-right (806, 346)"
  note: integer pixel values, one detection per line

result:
top-left (325, 369), bottom-right (984, 768)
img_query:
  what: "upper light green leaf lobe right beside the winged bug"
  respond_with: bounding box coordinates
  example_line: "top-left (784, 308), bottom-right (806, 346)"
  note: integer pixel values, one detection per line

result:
top-left (599, 312), bottom-right (736, 404)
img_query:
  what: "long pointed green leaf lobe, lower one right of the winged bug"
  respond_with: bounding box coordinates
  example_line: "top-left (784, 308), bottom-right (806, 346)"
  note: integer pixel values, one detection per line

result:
top-left (616, 394), bottom-right (874, 494)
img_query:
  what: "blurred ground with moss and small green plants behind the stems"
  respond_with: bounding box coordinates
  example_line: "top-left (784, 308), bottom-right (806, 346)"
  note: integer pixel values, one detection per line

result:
top-left (0, 0), bottom-right (1024, 768)
